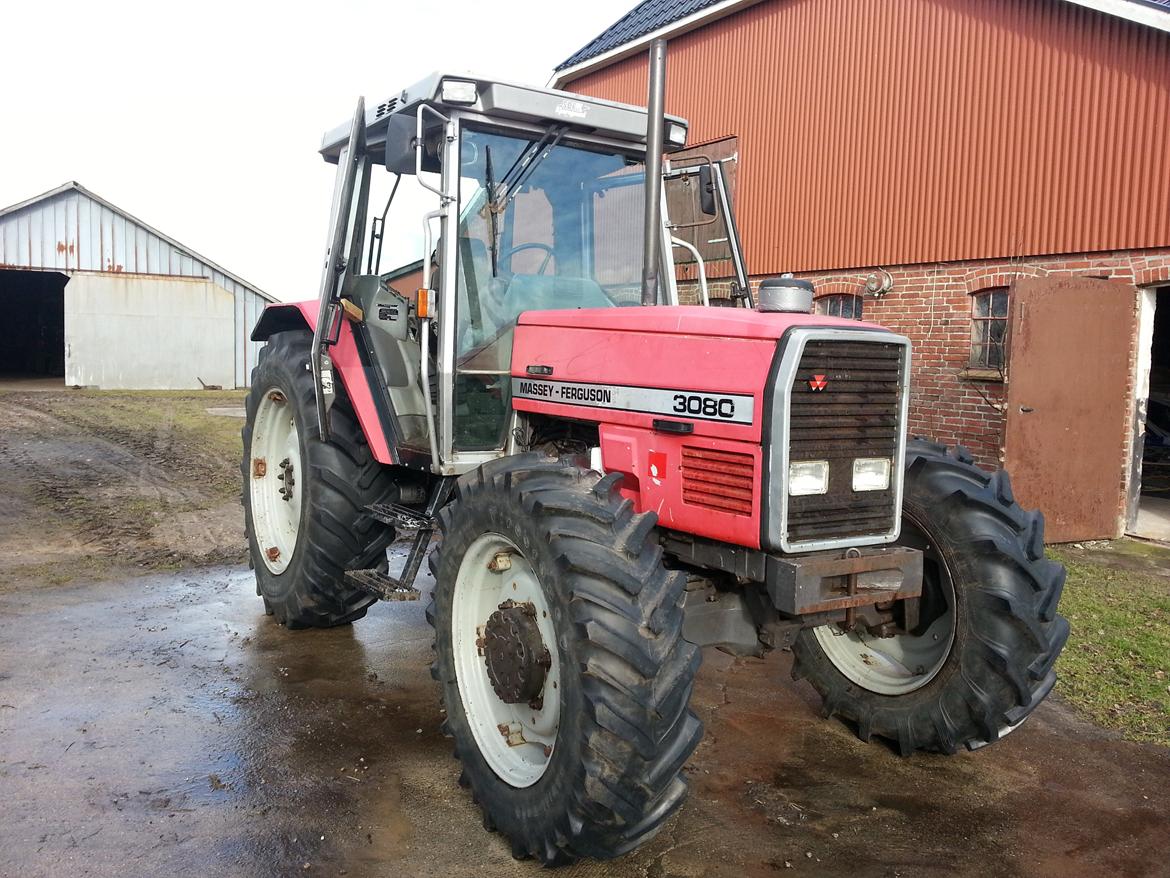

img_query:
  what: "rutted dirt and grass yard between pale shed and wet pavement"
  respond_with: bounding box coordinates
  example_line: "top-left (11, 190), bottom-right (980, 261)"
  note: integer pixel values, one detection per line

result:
top-left (0, 383), bottom-right (245, 591)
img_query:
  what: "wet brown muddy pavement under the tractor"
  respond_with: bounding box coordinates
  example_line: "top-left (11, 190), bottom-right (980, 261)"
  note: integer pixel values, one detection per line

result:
top-left (0, 557), bottom-right (1170, 878)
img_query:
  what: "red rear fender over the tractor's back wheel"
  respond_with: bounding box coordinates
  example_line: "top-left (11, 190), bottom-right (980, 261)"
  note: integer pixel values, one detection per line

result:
top-left (252, 301), bottom-right (399, 464)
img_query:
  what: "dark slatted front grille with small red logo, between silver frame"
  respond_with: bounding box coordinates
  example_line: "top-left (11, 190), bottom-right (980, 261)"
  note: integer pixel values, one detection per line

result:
top-left (787, 339), bottom-right (906, 543)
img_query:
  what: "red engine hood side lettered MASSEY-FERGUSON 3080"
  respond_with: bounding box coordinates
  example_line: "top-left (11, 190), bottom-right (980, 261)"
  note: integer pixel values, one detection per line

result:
top-left (511, 316), bottom-right (777, 548)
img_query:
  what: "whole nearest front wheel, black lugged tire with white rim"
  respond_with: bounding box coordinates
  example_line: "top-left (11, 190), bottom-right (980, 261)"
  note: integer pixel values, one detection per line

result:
top-left (427, 454), bottom-right (702, 865)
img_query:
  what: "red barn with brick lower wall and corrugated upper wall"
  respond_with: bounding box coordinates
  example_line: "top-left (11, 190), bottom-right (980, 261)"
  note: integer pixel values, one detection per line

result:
top-left (553, 0), bottom-right (1170, 540)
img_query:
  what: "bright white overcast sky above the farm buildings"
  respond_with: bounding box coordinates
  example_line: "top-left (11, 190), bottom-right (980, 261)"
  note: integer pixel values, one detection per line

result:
top-left (0, 0), bottom-right (636, 301)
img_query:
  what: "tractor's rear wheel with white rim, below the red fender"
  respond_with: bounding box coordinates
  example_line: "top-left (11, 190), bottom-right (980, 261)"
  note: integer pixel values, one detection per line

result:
top-left (241, 331), bottom-right (397, 629)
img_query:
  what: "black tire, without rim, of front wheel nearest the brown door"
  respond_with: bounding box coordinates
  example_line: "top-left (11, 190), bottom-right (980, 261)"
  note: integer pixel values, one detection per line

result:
top-left (793, 439), bottom-right (1068, 755)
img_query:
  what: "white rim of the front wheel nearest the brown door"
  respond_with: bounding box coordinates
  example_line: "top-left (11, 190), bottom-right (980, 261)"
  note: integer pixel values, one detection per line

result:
top-left (813, 521), bottom-right (956, 695)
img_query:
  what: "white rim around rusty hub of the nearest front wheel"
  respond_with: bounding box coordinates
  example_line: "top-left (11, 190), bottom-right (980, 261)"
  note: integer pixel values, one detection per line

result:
top-left (450, 534), bottom-right (560, 788)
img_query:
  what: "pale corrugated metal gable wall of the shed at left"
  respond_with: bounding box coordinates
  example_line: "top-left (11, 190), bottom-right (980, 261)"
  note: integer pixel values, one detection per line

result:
top-left (0, 181), bottom-right (276, 386)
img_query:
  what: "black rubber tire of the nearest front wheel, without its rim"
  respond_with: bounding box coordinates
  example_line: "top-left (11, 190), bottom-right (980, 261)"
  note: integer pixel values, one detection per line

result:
top-left (427, 454), bottom-right (702, 865)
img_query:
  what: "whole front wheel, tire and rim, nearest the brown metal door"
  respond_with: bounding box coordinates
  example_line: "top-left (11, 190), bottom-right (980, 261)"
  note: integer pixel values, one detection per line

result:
top-left (792, 440), bottom-right (1068, 755)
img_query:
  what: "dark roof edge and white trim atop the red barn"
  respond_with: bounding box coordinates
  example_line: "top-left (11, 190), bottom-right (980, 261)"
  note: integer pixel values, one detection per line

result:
top-left (556, 0), bottom-right (1170, 71)
